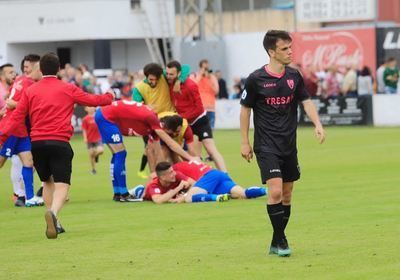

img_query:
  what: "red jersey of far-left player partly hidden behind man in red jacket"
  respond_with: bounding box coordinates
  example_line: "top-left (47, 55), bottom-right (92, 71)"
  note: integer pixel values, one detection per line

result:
top-left (0, 76), bottom-right (35, 137)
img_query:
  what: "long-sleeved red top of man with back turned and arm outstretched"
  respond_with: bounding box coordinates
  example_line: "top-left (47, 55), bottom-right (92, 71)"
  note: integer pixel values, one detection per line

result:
top-left (0, 76), bottom-right (113, 143)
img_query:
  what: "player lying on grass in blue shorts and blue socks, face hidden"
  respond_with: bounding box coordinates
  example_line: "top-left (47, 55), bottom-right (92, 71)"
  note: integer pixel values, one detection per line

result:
top-left (173, 161), bottom-right (267, 202)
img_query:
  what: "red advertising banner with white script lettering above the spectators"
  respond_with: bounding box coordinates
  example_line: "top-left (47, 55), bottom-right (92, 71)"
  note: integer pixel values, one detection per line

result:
top-left (292, 28), bottom-right (376, 73)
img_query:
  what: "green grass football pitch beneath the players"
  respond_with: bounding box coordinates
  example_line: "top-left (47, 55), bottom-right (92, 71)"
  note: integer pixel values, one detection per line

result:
top-left (0, 127), bottom-right (400, 279)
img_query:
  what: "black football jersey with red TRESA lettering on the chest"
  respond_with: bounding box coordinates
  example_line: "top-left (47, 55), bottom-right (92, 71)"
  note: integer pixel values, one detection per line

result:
top-left (240, 65), bottom-right (309, 156)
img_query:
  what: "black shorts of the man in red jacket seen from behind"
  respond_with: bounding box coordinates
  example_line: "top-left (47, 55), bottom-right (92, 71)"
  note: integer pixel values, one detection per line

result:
top-left (32, 140), bottom-right (74, 185)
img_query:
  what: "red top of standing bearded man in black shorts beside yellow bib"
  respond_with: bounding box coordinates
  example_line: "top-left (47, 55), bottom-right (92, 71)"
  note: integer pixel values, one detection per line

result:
top-left (169, 79), bottom-right (205, 124)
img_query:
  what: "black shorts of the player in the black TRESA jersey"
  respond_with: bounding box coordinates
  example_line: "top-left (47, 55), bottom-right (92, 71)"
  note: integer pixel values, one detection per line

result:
top-left (256, 153), bottom-right (300, 184)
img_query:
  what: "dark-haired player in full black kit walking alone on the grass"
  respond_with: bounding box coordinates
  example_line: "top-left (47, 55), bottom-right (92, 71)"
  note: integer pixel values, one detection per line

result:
top-left (240, 30), bottom-right (325, 256)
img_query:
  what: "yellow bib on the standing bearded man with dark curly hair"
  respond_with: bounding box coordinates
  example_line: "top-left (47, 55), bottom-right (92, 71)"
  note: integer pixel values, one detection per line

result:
top-left (136, 76), bottom-right (175, 114)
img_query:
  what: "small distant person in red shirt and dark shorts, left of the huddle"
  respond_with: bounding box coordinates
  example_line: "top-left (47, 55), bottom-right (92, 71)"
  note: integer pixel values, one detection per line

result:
top-left (82, 107), bottom-right (104, 174)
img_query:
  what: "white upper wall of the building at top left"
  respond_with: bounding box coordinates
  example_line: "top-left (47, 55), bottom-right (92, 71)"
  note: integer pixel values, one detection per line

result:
top-left (0, 0), bottom-right (175, 43)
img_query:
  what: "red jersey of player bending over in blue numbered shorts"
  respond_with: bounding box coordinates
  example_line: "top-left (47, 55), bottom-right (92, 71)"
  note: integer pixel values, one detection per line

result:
top-left (101, 100), bottom-right (161, 139)
